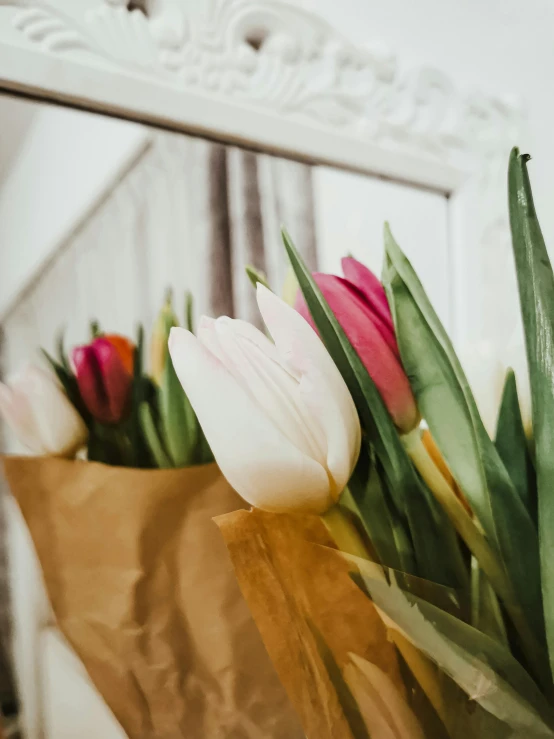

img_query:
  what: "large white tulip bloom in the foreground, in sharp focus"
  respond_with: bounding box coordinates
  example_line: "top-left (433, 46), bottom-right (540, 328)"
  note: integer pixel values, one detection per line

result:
top-left (169, 284), bottom-right (361, 513)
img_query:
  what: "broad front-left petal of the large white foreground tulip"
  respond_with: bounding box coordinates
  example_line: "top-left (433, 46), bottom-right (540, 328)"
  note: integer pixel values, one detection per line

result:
top-left (169, 328), bottom-right (334, 513)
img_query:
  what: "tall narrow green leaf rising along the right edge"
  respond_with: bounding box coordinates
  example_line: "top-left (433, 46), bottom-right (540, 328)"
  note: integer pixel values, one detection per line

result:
top-left (508, 149), bottom-right (554, 684)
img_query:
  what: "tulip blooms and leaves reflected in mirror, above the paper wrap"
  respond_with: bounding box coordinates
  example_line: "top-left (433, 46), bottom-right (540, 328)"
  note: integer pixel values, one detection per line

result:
top-left (0, 293), bottom-right (213, 469)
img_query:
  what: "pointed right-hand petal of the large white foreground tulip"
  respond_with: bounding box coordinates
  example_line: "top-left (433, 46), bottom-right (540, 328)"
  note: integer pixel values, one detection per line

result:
top-left (257, 284), bottom-right (361, 492)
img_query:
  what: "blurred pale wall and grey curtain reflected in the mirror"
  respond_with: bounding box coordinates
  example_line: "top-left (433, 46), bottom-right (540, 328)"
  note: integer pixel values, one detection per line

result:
top-left (0, 95), bottom-right (453, 739)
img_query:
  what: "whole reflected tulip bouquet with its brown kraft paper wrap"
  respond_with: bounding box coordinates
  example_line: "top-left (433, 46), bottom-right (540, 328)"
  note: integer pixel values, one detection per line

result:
top-left (0, 296), bottom-right (301, 739)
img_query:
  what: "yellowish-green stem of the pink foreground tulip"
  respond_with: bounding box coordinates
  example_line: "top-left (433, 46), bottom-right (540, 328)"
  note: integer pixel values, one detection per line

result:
top-left (401, 429), bottom-right (548, 684)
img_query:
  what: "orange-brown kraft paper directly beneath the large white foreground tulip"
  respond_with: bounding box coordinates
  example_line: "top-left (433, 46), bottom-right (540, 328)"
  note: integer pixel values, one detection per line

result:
top-left (216, 510), bottom-right (405, 739)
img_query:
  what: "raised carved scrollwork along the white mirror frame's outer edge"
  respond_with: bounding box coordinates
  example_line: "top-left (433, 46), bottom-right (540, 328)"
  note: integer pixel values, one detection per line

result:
top-left (0, 0), bottom-right (522, 344)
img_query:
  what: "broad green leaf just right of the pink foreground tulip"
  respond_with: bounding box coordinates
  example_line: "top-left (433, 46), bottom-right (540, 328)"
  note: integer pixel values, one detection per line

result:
top-left (384, 226), bottom-right (551, 684)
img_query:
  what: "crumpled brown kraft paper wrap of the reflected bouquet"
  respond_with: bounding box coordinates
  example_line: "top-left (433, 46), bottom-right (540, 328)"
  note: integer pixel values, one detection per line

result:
top-left (5, 457), bottom-right (303, 739)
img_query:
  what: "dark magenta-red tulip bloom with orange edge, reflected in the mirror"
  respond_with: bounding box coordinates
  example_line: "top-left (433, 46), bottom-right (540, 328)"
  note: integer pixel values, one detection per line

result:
top-left (72, 335), bottom-right (134, 424)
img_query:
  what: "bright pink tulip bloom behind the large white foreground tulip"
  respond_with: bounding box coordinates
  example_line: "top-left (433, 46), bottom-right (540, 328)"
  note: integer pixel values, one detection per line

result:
top-left (295, 257), bottom-right (419, 433)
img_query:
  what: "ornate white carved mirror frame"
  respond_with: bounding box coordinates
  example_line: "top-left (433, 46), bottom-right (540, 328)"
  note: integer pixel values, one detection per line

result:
top-left (0, 0), bottom-right (520, 340)
